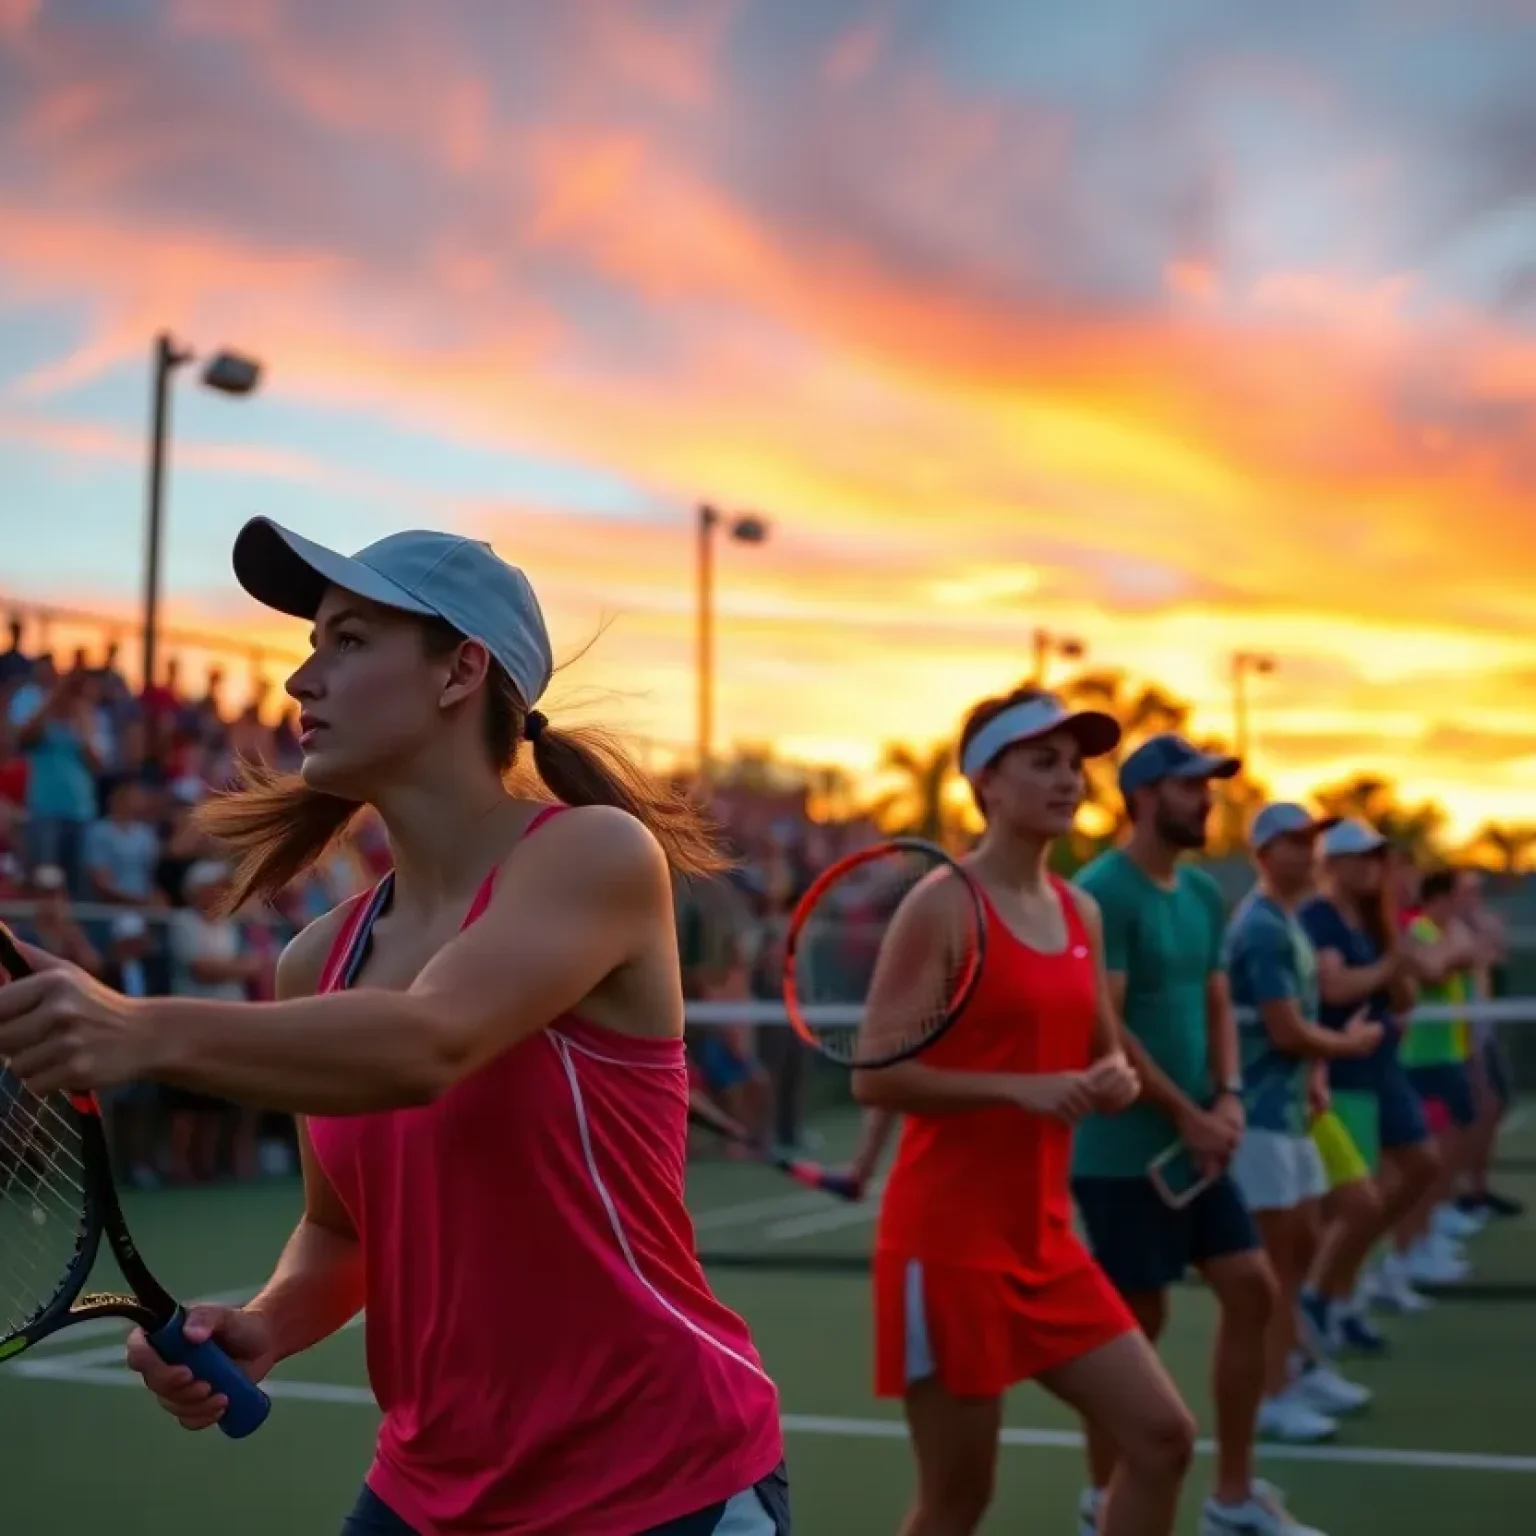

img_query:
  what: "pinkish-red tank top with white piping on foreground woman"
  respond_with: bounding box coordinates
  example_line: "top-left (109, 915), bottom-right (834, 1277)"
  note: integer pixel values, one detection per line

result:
top-left (309, 811), bottom-right (783, 1536)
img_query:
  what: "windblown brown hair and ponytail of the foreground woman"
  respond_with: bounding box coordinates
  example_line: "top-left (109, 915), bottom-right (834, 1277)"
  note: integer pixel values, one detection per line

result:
top-left (194, 619), bottom-right (730, 911)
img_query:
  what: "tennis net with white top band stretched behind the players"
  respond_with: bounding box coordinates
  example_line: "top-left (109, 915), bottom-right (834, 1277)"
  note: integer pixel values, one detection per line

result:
top-left (688, 997), bottom-right (1536, 1301)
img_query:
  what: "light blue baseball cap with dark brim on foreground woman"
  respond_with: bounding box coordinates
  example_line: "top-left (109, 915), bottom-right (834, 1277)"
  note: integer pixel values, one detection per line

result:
top-left (235, 518), bottom-right (554, 708)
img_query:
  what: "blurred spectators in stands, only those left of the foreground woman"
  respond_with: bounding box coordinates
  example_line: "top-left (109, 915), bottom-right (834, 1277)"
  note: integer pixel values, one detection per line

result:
top-left (0, 624), bottom-right (386, 1187)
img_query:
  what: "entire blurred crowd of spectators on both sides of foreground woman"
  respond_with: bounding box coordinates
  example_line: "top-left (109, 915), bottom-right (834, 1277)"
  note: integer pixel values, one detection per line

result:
top-left (0, 622), bottom-right (876, 1187)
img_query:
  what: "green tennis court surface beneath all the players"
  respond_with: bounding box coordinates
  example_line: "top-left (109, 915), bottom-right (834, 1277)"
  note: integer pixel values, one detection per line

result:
top-left (0, 1120), bottom-right (1536, 1536)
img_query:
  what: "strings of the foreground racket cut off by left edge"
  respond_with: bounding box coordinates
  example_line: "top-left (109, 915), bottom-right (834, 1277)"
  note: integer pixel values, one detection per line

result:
top-left (0, 1068), bottom-right (86, 1339)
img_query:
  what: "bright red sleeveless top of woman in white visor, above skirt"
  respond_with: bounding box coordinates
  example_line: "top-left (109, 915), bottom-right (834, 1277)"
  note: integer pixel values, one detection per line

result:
top-left (876, 879), bottom-right (1097, 1284)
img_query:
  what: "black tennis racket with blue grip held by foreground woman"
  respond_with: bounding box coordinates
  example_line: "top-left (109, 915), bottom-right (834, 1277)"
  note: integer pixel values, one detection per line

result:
top-left (0, 923), bottom-right (272, 1439)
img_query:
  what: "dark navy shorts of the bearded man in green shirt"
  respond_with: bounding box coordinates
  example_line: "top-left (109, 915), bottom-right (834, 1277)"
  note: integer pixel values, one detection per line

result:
top-left (1072, 1175), bottom-right (1260, 1296)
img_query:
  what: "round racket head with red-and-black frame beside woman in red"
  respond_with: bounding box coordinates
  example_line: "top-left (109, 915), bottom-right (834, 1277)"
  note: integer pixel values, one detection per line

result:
top-left (783, 837), bottom-right (986, 1069)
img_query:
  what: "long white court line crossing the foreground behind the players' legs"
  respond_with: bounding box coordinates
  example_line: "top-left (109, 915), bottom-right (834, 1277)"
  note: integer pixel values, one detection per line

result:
top-left (12, 1361), bottom-right (1536, 1476)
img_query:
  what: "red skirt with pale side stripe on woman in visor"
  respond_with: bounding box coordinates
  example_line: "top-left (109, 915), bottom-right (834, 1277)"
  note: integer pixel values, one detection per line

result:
top-left (874, 1252), bottom-right (1137, 1398)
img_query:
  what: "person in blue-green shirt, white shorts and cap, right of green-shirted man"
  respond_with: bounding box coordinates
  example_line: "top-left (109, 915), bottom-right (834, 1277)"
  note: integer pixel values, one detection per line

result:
top-left (1224, 803), bottom-right (1381, 1462)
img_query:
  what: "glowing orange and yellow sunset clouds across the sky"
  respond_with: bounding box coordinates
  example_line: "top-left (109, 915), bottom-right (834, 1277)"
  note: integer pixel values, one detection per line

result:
top-left (9, 0), bottom-right (1536, 841)
